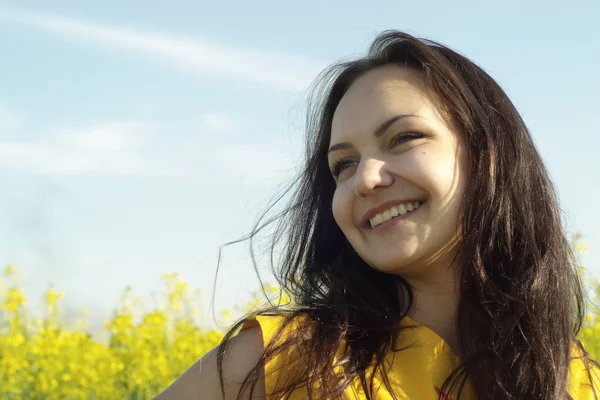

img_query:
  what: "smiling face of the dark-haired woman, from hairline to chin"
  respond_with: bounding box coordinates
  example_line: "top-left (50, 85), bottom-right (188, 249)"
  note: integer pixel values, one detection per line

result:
top-left (328, 66), bottom-right (466, 277)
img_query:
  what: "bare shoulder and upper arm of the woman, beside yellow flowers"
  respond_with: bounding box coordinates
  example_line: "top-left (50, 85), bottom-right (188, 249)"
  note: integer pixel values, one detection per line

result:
top-left (154, 325), bottom-right (265, 400)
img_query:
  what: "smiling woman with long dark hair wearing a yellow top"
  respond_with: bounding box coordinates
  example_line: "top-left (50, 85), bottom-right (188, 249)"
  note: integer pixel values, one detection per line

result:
top-left (157, 31), bottom-right (600, 400)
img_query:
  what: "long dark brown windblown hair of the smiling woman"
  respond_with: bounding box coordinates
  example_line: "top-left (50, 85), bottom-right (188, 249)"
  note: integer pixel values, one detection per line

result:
top-left (213, 31), bottom-right (592, 400)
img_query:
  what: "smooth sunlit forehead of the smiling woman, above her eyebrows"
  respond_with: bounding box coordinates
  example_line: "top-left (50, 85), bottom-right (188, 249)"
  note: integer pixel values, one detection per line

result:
top-left (331, 65), bottom-right (439, 142)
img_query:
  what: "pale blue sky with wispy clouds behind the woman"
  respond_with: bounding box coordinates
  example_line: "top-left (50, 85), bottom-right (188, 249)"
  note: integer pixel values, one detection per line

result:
top-left (0, 0), bottom-right (600, 338)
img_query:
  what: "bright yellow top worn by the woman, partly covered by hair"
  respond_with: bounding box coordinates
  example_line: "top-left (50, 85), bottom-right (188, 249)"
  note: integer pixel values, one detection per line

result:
top-left (242, 316), bottom-right (600, 400)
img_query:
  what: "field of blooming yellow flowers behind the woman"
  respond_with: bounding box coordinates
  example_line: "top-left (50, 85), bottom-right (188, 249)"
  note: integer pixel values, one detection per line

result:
top-left (0, 260), bottom-right (600, 400)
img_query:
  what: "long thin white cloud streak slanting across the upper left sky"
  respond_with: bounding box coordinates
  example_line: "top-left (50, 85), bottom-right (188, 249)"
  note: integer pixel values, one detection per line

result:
top-left (0, 9), bottom-right (322, 91)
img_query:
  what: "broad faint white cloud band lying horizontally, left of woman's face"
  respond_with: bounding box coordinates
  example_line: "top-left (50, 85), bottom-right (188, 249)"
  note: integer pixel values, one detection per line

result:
top-left (0, 113), bottom-right (292, 184)
